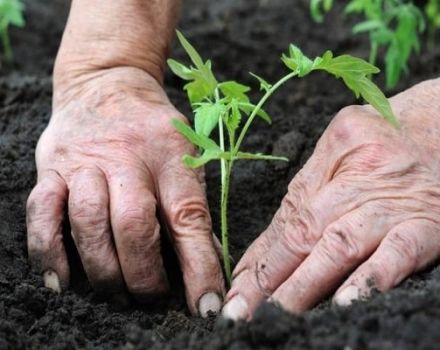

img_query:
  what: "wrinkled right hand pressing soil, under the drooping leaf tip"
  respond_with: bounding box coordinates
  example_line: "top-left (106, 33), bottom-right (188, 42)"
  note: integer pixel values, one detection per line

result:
top-left (223, 79), bottom-right (440, 319)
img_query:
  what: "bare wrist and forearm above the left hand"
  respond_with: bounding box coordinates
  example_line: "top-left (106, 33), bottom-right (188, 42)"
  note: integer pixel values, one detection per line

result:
top-left (54, 0), bottom-right (180, 95)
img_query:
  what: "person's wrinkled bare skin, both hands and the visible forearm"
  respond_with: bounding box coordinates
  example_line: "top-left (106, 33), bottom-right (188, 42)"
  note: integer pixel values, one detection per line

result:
top-left (27, 0), bottom-right (440, 319)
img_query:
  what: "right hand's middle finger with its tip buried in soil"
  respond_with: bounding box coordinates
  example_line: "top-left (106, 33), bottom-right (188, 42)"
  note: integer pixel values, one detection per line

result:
top-left (272, 202), bottom-right (400, 312)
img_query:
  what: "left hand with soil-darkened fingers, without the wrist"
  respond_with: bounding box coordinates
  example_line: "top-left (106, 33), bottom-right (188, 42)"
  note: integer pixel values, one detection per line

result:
top-left (27, 68), bottom-right (223, 316)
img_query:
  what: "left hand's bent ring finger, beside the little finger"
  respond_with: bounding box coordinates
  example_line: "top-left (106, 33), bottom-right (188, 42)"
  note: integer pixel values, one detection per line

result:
top-left (69, 168), bottom-right (123, 294)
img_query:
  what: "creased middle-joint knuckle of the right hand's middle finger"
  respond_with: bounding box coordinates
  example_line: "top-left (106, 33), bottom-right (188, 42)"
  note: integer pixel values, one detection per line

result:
top-left (321, 225), bottom-right (362, 265)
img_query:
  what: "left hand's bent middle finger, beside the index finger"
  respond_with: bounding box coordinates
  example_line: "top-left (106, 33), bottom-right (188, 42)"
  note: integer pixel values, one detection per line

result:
top-left (109, 170), bottom-right (168, 302)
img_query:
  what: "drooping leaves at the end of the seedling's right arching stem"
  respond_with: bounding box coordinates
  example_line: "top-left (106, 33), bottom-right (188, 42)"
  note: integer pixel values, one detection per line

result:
top-left (282, 45), bottom-right (399, 127)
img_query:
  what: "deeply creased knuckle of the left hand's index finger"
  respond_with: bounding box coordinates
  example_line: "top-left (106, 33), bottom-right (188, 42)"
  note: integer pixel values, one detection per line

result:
top-left (168, 197), bottom-right (211, 235)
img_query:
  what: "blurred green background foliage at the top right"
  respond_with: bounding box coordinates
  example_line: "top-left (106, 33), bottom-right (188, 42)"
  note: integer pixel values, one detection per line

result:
top-left (310, 0), bottom-right (425, 88)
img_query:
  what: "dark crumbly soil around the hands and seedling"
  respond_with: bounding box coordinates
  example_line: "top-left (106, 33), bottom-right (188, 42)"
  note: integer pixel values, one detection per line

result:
top-left (0, 0), bottom-right (440, 350)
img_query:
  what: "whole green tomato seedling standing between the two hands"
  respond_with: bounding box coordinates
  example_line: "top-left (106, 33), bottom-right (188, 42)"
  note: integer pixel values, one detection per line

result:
top-left (168, 32), bottom-right (398, 282)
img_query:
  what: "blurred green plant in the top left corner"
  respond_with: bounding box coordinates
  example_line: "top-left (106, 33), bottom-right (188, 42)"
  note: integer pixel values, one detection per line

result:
top-left (0, 0), bottom-right (25, 64)
